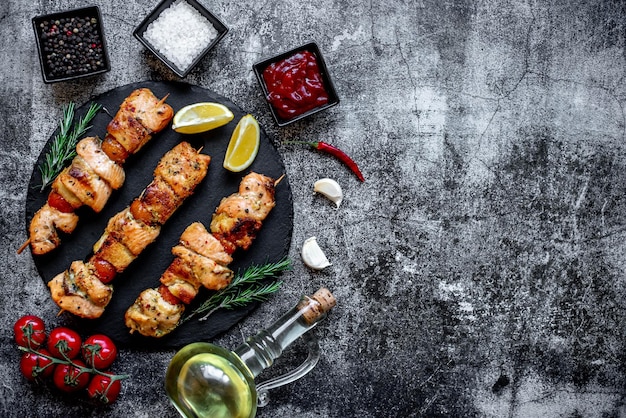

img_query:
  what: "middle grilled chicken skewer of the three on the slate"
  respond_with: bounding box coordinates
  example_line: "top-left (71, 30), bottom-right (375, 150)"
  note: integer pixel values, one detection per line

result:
top-left (48, 142), bottom-right (211, 319)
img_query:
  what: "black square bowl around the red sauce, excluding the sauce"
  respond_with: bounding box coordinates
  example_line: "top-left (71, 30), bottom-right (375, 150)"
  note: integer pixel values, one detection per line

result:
top-left (252, 42), bottom-right (339, 126)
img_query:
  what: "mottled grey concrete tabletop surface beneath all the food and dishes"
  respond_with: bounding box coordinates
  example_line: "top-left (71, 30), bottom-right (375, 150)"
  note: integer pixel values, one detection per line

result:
top-left (0, 0), bottom-right (626, 418)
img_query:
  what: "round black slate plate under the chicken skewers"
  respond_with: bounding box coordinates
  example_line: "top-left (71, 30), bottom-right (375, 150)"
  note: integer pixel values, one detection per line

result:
top-left (26, 82), bottom-right (293, 349)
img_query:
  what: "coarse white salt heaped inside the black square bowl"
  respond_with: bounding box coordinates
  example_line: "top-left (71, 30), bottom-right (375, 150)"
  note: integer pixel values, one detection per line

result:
top-left (144, 0), bottom-right (218, 71)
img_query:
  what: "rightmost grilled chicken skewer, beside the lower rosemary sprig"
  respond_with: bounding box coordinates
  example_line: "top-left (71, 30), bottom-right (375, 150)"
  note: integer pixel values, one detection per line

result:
top-left (125, 172), bottom-right (280, 337)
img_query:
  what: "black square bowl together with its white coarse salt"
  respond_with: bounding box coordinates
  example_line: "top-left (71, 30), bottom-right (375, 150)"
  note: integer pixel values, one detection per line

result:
top-left (133, 0), bottom-right (228, 77)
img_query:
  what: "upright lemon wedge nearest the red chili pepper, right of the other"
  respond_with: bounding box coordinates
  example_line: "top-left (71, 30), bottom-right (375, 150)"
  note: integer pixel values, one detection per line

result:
top-left (224, 115), bottom-right (261, 173)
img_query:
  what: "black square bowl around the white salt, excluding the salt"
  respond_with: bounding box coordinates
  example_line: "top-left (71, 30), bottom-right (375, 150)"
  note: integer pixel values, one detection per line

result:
top-left (133, 0), bottom-right (228, 77)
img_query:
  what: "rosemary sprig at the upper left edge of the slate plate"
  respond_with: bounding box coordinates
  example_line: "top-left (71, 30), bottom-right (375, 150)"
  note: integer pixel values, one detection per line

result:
top-left (39, 102), bottom-right (102, 191)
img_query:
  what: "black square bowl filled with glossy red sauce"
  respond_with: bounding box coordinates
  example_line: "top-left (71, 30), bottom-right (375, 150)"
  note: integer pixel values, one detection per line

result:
top-left (253, 42), bottom-right (339, 126)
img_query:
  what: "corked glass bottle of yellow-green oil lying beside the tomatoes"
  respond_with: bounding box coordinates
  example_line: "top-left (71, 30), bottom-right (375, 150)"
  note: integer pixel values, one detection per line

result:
top-left (165, 289), bottom-right (335, 418)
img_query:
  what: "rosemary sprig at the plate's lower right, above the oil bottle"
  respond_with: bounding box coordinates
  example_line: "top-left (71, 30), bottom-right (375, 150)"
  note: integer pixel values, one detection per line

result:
top-left (181, 257), bottom-right (291, 323)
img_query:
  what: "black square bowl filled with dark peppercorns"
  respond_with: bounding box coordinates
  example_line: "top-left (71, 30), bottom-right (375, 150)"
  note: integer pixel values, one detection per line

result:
top-left (32, 6), bottom-right (111, 83)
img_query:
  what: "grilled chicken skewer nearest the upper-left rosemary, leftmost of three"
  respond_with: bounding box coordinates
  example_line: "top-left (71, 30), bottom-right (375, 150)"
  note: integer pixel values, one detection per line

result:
top-left (18, 88), bottom-right (174, 255)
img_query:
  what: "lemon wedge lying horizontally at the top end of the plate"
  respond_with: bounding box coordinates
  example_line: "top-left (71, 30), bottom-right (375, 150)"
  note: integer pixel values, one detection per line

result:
top-left (172, 102), bottom-right (235, 134)
